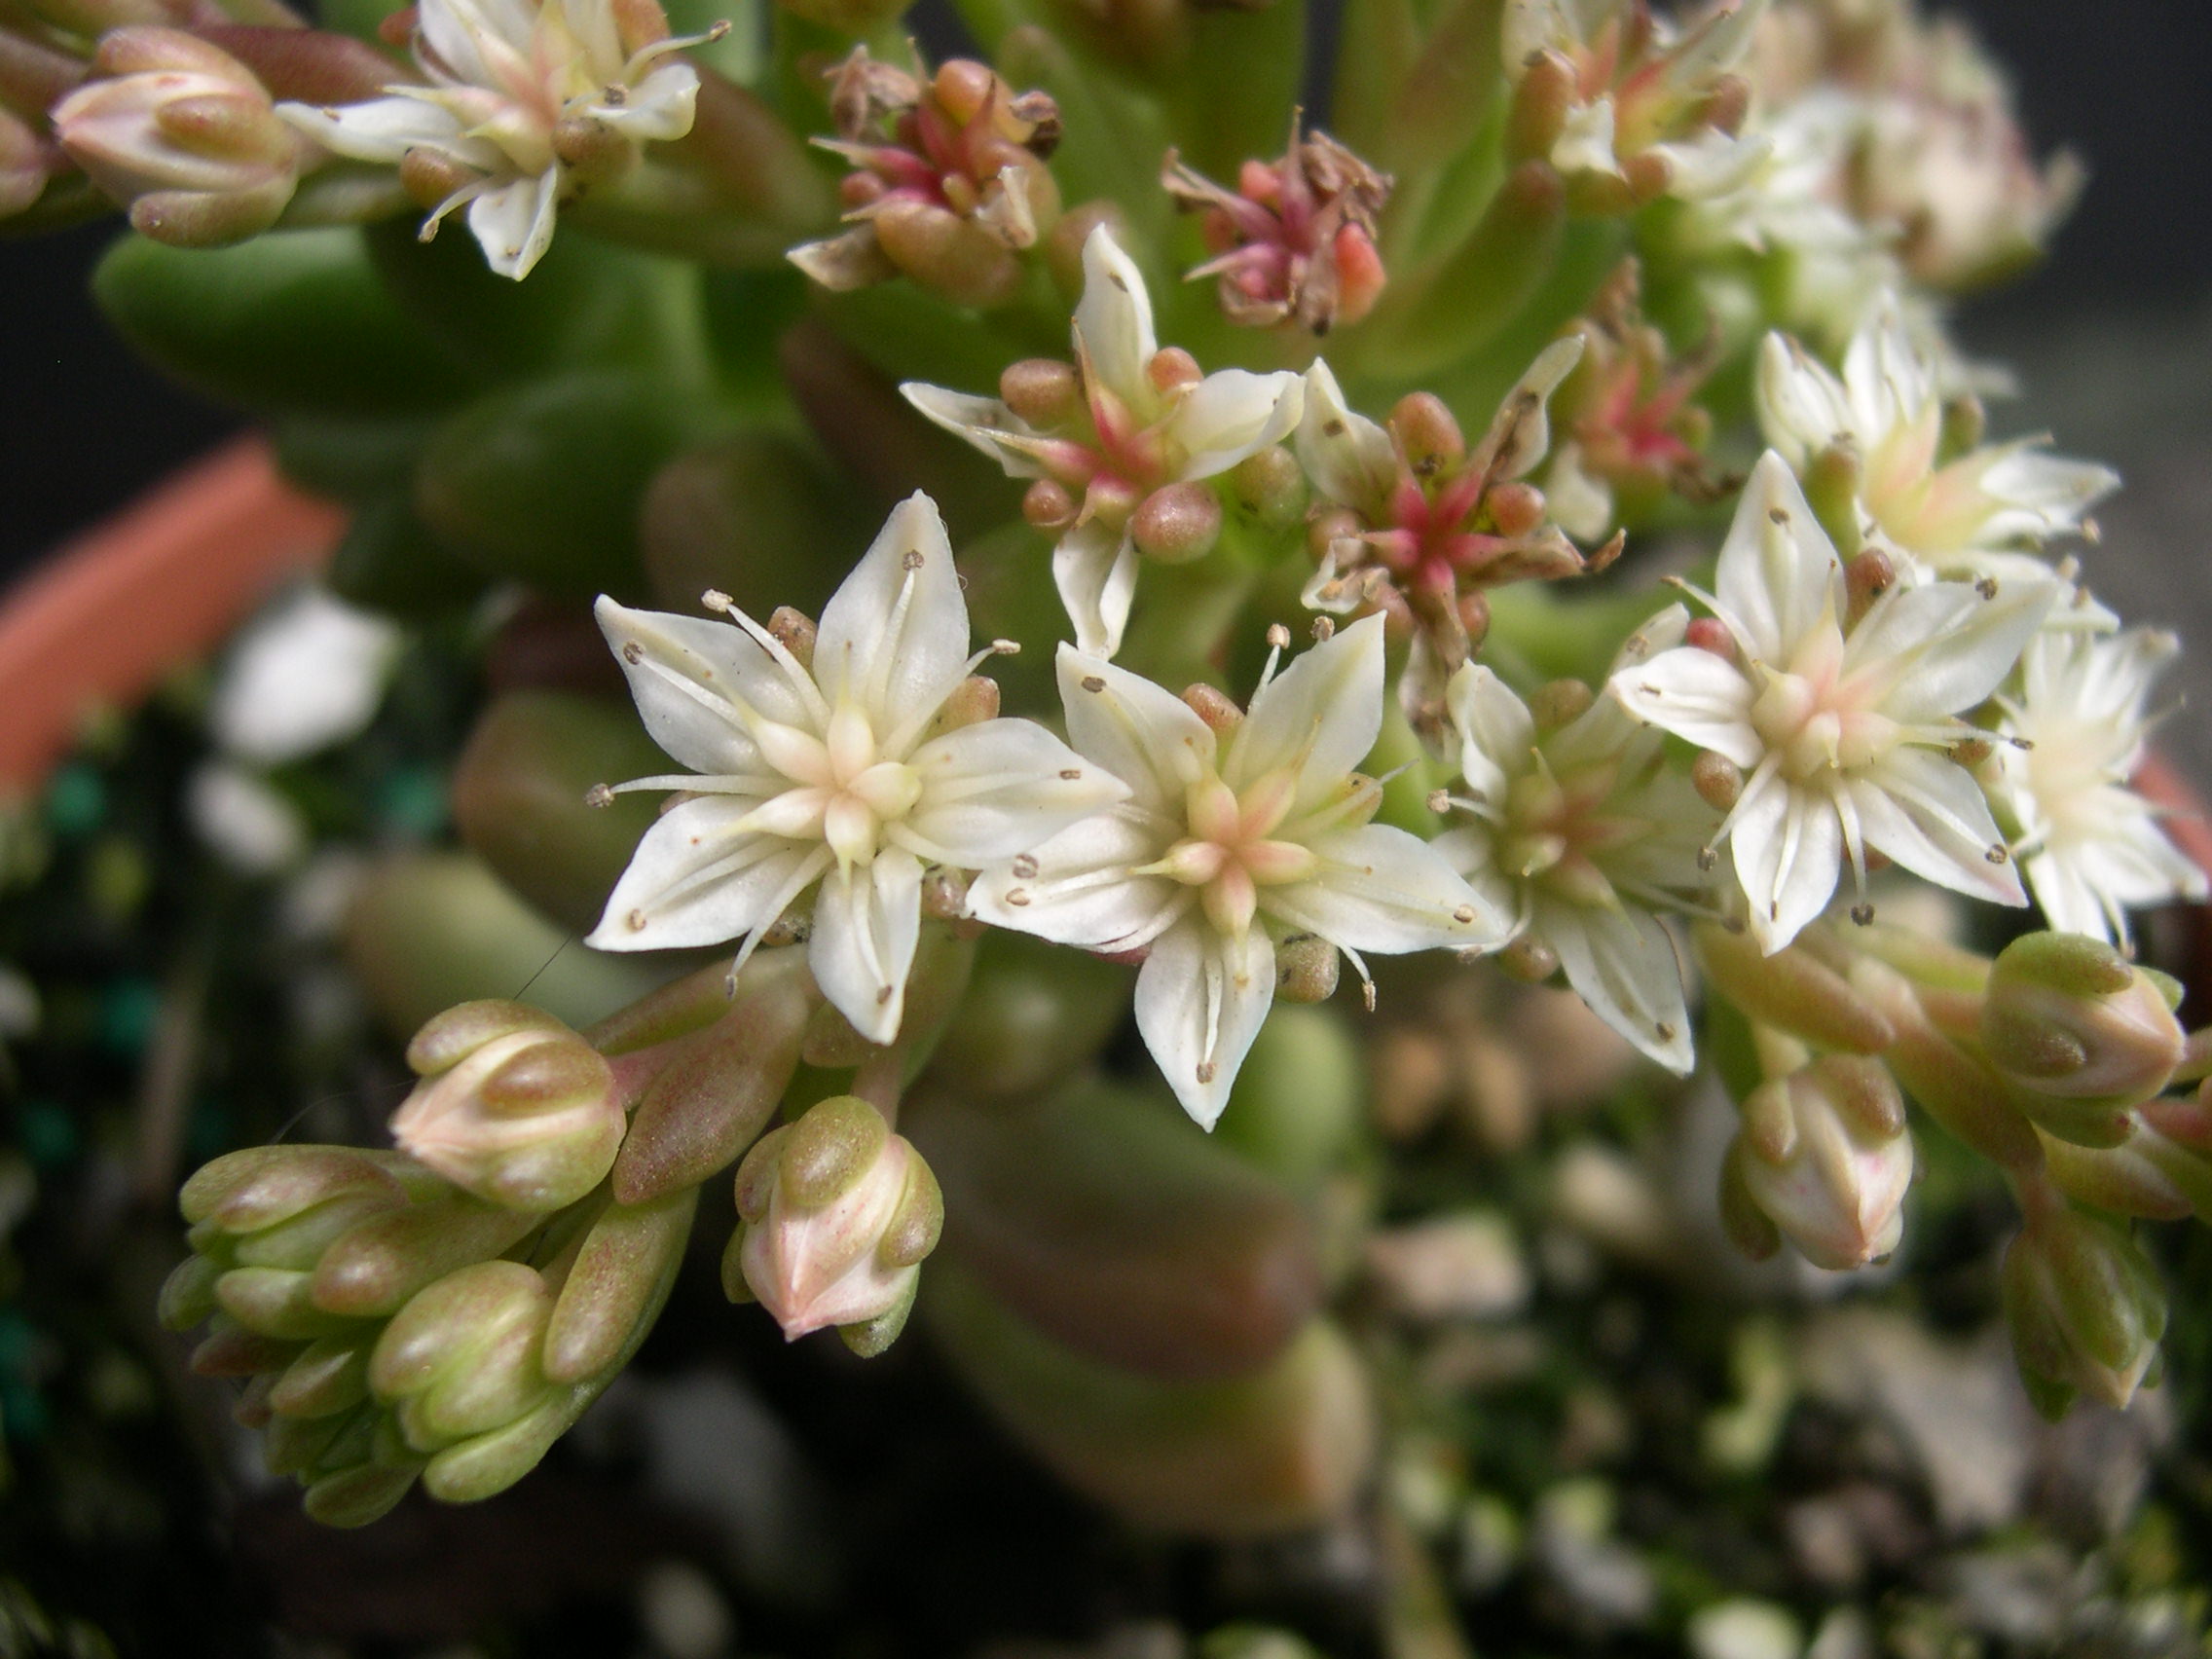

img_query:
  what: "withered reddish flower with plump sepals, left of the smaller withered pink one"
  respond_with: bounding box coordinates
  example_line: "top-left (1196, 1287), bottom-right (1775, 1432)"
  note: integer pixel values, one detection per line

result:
top-left (790, 47), bottom-right (1059, 306)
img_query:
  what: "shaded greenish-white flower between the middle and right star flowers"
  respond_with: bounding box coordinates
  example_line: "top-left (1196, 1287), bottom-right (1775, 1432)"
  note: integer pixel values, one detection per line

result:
top-left (1436, 607), bottom-right (1718, 1073)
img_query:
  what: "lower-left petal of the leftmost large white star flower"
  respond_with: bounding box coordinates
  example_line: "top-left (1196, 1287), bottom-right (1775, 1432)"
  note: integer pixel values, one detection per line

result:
top-left (584, 794), bottom-right (830, 951)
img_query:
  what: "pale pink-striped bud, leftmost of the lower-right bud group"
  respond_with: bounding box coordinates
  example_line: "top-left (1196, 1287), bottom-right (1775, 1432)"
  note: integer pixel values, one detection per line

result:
top-left (1723, 1055), bottom-right (1913, 1270)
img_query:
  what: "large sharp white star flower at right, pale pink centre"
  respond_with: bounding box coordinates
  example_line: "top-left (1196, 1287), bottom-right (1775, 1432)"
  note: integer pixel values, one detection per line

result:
top-left (1610, 449), bottom-right (2055, 953)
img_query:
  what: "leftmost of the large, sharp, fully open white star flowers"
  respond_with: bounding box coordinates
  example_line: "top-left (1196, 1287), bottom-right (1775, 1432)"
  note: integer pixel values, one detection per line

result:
top-left (586, 496), bottom-right (1128, 1042)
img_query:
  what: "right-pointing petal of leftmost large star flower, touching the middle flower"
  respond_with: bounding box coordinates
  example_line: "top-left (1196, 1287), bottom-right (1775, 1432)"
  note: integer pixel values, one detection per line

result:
top-left (892, 719), bottom-right (1128, 869)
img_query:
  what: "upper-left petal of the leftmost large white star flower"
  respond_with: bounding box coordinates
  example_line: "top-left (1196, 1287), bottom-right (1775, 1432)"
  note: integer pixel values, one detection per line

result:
top-left (593, 595), bottom-right (821, 776)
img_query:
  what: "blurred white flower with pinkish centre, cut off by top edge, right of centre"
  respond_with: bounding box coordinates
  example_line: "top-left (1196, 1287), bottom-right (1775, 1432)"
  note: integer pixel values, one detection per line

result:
top-left (1504, 0), bottom-right (1761, 212)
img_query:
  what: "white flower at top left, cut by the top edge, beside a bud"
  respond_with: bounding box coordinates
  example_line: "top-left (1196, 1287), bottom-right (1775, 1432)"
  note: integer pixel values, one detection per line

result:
top-left (276, 0), bottom-right (708, 281)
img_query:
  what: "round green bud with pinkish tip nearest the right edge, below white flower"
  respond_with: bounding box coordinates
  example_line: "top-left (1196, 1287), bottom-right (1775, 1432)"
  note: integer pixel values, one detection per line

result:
top-left (1982, 934), bottom-right (2183, 1146)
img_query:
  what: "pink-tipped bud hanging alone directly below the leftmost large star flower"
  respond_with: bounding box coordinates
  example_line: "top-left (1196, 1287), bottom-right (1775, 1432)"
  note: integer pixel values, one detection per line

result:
top-left (723, 1095), bottom-right (944, 1353)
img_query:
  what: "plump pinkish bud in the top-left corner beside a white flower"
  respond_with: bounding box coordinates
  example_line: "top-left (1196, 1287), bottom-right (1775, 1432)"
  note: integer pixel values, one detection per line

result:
top-left (54, 26), bottom-right (301, 247)
